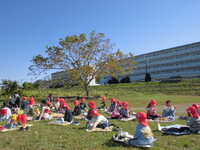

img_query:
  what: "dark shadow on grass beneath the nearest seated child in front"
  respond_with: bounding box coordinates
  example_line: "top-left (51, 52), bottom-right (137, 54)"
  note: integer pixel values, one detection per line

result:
top-left (103, 139), bottom-right (149, 150)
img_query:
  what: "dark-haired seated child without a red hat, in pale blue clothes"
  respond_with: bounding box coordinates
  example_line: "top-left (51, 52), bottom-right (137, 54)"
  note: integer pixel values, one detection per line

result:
top-left (162, 100), bottom-right (176, 117)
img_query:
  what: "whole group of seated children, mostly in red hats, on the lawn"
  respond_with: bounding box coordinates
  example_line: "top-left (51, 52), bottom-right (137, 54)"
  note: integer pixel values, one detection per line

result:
top-left (0, 94), bottom-right (200, 146)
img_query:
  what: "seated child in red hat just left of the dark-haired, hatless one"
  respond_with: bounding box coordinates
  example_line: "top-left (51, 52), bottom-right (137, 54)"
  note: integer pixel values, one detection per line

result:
top-left (146, 99), bottom-right (161, 120)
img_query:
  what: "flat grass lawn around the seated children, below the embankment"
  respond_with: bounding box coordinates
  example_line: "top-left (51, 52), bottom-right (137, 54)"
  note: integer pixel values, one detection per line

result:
top-left (0, 91), bottom-right (200, 150)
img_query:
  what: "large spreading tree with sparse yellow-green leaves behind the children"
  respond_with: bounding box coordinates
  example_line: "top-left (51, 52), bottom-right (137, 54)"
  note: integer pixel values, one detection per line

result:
top-left (29, 31), bottom-right (135, 96)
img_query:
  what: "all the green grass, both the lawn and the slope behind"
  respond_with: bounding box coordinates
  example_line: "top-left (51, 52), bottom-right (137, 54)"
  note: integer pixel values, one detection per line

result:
top-left (0, 80), bottom-right (200, 150)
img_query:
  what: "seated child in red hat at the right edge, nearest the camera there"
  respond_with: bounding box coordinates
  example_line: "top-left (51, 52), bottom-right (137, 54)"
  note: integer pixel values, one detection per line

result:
top-left (186, 106), bottom-right (200, 132)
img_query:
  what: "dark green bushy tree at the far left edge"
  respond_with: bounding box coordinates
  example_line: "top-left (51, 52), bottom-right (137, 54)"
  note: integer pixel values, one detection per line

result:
top-left (1, 80), bottom-right (19, 95)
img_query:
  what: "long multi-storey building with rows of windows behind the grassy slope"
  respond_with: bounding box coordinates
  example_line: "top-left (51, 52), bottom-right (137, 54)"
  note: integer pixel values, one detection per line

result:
top-left (100, 42), bottom-right (200, 85)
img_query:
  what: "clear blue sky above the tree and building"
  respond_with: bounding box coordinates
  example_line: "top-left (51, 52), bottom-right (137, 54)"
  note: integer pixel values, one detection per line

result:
top-left (0, 0), bottom-right (200, 82)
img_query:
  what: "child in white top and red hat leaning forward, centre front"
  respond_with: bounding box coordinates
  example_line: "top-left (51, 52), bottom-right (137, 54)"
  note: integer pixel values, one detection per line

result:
top-left (87, 109), bottom-right (109, 130)
